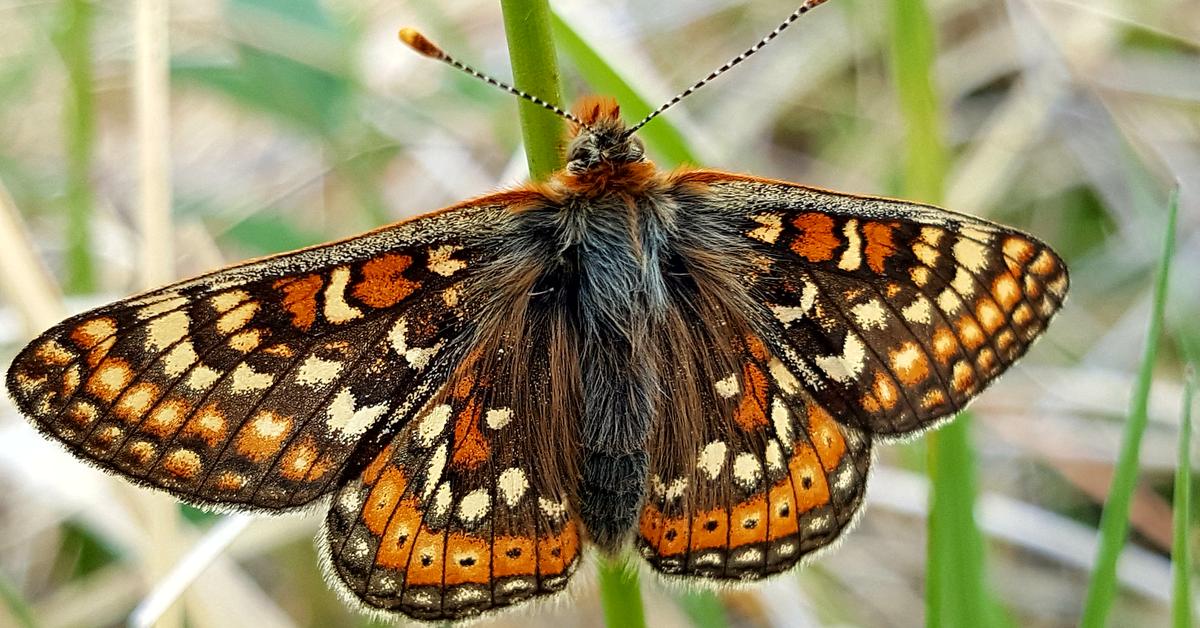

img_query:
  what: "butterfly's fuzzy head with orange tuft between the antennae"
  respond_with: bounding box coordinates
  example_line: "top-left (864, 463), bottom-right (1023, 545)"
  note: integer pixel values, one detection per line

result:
top-left (566, 97), bottom-right (646, 174)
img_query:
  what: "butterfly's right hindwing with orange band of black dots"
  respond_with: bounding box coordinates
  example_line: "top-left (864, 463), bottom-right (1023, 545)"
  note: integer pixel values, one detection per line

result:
top-left (635, 284), bottom-right (871, 580)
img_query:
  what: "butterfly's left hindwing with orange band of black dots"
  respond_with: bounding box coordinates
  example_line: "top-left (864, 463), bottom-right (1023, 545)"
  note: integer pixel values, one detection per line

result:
top-left (322, 279), bottom-right (583, 621)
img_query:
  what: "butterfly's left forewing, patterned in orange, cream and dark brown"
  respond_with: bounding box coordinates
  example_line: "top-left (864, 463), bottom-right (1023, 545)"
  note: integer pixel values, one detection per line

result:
top-left (7, 193), bottom-right (540, 510)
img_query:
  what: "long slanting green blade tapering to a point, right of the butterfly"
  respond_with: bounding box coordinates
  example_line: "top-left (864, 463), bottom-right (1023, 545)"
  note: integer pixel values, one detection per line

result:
top-left (1080, 193), bottom-right (1178, 628)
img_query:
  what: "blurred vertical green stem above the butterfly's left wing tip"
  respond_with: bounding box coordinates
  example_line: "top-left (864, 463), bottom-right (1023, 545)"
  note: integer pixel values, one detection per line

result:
top-left (54, 0), bottom-right (96, 293)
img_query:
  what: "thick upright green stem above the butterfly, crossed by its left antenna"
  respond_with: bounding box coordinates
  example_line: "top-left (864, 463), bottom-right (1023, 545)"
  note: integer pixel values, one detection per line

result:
top-left (500, 0), bottom-right (564, 180)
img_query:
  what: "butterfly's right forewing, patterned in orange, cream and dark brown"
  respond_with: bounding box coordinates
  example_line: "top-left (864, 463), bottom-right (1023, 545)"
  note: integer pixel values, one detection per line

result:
top-left (680, 172), bottom-right (1068, 437)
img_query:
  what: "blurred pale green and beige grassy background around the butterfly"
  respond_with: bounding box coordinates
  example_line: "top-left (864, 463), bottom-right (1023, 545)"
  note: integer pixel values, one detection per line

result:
top-left (0, 0), bottom-right (1200, 628)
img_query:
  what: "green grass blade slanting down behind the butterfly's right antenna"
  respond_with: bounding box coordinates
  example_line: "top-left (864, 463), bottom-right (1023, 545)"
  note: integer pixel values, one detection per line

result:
top-left (551, 13), bottom-right (697, 166)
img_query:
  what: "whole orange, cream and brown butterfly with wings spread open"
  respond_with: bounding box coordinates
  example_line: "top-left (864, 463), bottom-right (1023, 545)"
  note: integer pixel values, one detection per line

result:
top-left (7, 3), bottom-right (1068, 620)
